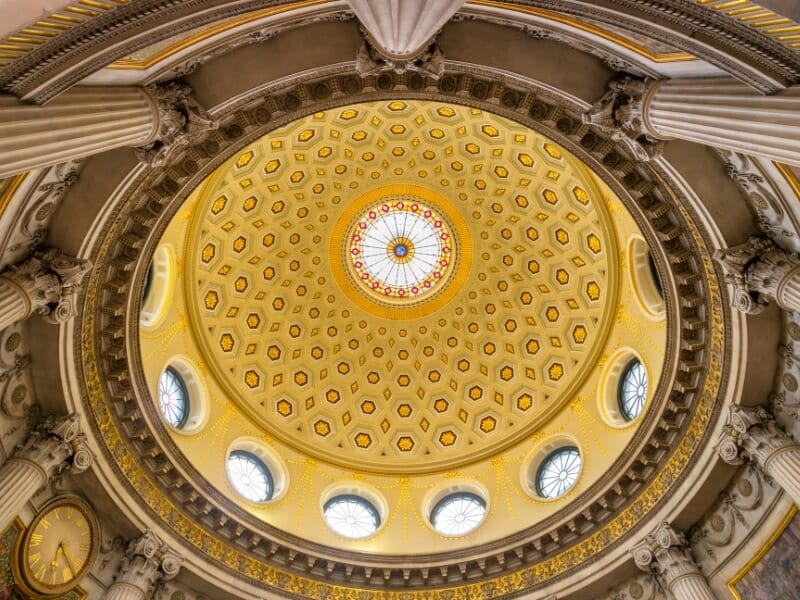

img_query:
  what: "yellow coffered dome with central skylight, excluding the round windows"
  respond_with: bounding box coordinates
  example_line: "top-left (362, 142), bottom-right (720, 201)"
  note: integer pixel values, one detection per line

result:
top-left (140, 100), bottom-right (666, 554)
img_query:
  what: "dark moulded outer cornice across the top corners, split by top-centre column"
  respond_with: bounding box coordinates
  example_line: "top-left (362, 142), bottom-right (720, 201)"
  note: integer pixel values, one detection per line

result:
top-left (0, 0), bottom-right (800, 103)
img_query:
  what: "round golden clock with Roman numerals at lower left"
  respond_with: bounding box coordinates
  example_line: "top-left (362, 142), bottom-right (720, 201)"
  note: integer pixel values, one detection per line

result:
top-left (21, 498), bottom-right (97, 595)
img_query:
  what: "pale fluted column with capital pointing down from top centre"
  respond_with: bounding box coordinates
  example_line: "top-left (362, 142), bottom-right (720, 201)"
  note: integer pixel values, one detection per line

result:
top-left (347, 0), bottom-right (465, 78)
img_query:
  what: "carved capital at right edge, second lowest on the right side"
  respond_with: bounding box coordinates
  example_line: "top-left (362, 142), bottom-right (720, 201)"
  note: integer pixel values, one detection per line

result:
top-left (718, 406), bottom-right (796, 472)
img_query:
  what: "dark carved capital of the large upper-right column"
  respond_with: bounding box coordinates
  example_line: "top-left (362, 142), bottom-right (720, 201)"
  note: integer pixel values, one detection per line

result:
top-left (583, 75), bottom-right (662, 161)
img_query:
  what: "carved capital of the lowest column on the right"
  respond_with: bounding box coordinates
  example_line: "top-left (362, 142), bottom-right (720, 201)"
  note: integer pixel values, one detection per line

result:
top-left (631, 521), bottom-right (700, 589)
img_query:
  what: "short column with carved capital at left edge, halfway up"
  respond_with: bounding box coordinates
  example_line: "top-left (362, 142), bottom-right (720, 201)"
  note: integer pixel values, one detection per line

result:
top-left (0, 248), bottom-right (92, 330)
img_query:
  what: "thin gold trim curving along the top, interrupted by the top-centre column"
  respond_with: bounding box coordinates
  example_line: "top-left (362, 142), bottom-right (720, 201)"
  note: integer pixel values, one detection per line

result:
top-left (106, 0), bottom-right (697, 71)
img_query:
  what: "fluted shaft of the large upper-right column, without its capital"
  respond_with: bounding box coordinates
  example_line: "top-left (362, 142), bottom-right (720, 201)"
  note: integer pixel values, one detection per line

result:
top-left (642, 78), bottom-right (800, 166)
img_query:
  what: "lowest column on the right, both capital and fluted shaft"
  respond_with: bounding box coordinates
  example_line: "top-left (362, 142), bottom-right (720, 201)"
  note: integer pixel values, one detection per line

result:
top-left (631, 522), bottom-right (716, 600)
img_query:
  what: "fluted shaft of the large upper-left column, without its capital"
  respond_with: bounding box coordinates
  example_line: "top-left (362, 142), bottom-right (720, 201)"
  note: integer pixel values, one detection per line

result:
top-left (0, 86), bottom-right (159, 178)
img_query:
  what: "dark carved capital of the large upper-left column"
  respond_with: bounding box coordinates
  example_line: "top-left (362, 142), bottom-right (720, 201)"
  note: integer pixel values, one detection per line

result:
top-left (136, 80), bottom-right (219, 166)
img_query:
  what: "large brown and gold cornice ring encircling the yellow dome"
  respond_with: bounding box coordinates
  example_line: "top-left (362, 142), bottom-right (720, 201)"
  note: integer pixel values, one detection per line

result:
top-left (75, 65), bottom-right (734, 599)
